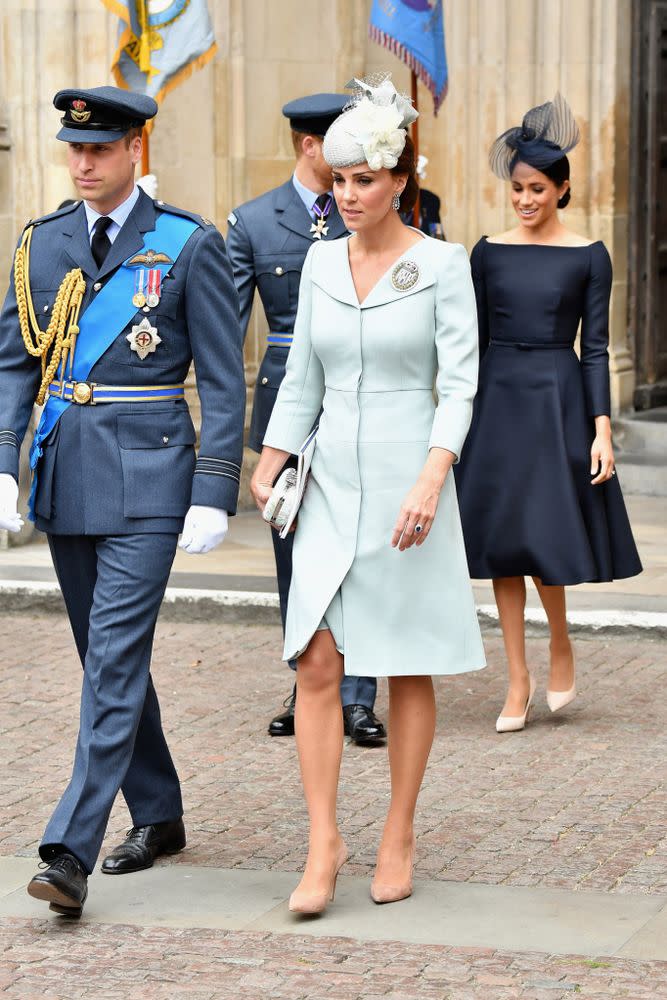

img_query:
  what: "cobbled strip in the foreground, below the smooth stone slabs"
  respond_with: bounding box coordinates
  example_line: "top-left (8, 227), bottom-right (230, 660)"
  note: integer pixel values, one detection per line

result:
top-left (0, 920), bottom-right (667, 1000)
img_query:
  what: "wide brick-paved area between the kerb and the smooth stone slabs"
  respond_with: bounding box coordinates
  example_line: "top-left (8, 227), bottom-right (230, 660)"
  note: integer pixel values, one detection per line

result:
top-left (0, 615), bottom-right (667, 892)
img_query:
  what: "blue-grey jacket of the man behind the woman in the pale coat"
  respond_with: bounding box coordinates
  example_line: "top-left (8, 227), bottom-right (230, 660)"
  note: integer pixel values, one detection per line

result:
top-left (227, 178), bottom-right (347, 451)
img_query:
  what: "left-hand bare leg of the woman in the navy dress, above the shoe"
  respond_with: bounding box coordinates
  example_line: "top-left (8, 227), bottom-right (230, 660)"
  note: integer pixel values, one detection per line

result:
top-left (493, 576), bottom-right (530, 717)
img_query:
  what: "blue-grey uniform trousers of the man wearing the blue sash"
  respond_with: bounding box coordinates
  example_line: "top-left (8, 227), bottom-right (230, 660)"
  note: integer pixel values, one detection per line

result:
top-left (39, 533), bottom-right (183, 872)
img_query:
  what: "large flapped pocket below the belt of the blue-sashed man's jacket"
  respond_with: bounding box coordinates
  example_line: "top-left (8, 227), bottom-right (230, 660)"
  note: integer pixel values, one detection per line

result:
top-left (118, 409), bottom-right (195, 517)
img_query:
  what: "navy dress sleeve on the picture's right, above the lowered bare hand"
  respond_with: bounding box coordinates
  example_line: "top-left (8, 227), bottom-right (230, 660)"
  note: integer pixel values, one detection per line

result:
top-left (581, 243), bottom-right (612, 417)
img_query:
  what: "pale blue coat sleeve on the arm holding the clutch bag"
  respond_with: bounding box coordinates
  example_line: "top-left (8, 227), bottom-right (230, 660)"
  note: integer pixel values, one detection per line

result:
top-left (264, 244), bottom-right (324, 454)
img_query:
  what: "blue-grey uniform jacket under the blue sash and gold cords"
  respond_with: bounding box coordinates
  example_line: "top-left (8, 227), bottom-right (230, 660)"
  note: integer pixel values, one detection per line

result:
top-left (0, 192), bottom-right (245, 535)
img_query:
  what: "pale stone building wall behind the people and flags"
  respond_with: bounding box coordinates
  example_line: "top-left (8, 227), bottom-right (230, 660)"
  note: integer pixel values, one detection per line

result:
top-left (0, 0), bottom-right (634, 422)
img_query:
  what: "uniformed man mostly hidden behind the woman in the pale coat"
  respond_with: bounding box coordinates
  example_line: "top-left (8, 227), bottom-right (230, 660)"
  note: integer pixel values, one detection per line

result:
top-left (227, 94), bottom-right (386, 745)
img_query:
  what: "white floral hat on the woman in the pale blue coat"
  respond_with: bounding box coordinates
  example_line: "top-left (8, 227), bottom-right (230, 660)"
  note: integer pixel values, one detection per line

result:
top-left (323, 75), bottom-right (418, 170)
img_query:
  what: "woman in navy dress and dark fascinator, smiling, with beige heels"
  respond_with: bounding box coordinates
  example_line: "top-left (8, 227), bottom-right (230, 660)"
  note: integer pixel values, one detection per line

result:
top-left (455, 94), bottom-right (642, 732)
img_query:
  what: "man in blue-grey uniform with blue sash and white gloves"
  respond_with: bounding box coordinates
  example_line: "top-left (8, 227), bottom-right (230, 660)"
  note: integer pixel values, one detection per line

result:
top-left (0, 87), bottom-right (245, 916)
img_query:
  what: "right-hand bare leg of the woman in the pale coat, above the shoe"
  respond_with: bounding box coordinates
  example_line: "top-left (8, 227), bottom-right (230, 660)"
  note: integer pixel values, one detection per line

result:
top-left (375, 677), bottom-right (435, 886)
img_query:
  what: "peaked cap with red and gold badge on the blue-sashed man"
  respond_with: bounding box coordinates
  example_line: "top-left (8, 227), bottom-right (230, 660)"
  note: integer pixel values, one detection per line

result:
top-left (53, 87), bottom-right (157, 142)
